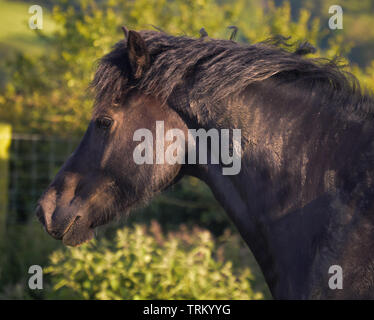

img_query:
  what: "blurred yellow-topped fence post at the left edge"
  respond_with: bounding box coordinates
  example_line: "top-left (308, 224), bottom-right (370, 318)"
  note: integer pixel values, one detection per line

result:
top-left (0, 123), bottom-right (12, 236)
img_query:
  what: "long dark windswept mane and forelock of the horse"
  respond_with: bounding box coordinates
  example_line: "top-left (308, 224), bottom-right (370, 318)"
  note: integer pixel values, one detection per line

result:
top-left (92, 31), bottom-right (373, 120)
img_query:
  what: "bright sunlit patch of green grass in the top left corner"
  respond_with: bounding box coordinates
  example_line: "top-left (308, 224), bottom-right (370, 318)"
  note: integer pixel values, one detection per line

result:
top-left (0, 0), bottom-right (55, 54)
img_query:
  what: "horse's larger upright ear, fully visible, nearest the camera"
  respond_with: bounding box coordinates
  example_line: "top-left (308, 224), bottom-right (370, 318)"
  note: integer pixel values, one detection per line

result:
top-left (127, 30), bottom-right (150, 79)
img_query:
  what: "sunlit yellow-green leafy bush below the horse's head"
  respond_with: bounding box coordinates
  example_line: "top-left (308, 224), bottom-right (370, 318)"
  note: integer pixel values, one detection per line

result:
top-left (46, 222), bottom-right (263, 299)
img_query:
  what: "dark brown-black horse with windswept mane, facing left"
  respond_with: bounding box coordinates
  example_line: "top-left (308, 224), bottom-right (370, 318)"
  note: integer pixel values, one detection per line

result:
top-left (37, 29), bottom-right (374, 299)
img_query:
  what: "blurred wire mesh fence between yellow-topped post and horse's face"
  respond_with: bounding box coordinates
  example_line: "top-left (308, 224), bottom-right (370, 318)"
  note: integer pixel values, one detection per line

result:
top-left (7, 134), bottom-right (78, 223)
